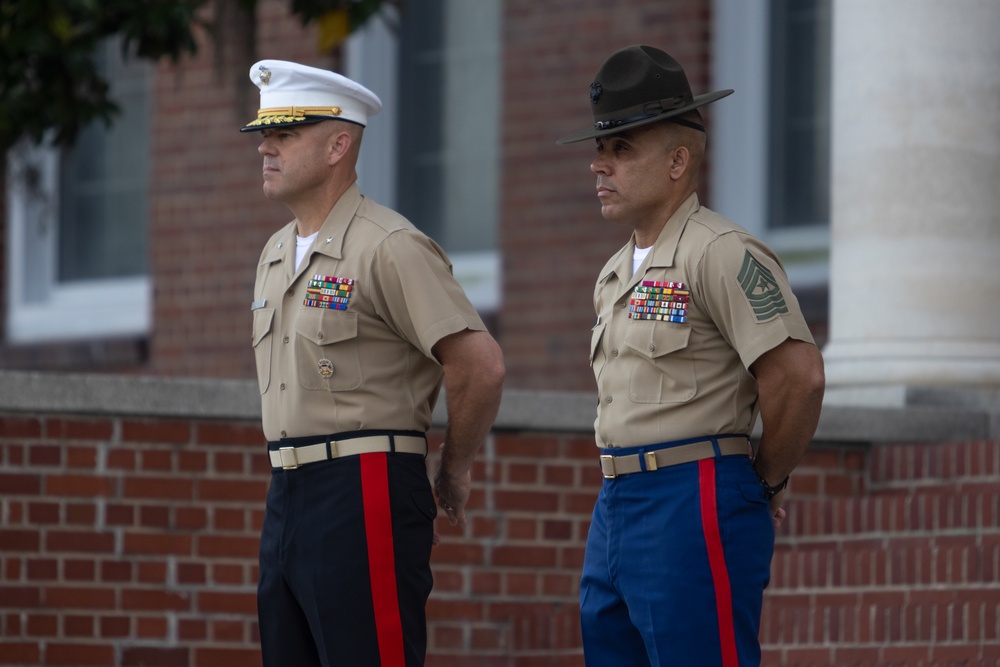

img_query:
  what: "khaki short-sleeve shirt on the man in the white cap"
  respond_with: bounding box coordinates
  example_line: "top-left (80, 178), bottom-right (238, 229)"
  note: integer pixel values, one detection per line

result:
top-left (252, 185), bottom-right (485, 440)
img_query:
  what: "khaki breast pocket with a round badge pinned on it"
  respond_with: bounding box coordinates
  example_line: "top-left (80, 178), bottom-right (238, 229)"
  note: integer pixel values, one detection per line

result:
top-left (295, 307), bottom-right (362, 391)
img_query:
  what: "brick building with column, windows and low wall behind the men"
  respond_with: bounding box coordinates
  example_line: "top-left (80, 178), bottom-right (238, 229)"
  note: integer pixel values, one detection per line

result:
top-left (0, 0), bottom-right (1000, 667)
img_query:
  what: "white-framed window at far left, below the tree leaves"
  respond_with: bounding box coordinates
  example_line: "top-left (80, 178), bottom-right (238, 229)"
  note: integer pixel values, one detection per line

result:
top-left (7, 40), bottom-right (152, 343)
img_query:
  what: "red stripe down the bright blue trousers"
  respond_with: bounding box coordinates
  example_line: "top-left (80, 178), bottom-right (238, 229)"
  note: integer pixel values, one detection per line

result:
top-left (698, 459), bottom-right (739, 667)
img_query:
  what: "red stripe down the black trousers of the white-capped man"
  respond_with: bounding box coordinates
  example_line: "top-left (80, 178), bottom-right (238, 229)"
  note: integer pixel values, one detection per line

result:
top-left (360, 453), bottom-right (406, 667)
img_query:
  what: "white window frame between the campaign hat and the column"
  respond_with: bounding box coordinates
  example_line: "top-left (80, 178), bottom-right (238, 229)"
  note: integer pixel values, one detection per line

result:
top-left (709, 0), bottom-right (830, 287)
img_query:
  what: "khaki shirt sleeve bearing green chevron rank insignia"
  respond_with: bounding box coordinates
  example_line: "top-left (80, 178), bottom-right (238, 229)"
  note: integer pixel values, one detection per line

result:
top-left (696, 232), bottom-right (814, 369)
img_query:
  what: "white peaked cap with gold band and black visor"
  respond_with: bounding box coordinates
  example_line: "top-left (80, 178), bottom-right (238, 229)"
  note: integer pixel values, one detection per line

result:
top-left (241, 60), bottom-right (382, 132)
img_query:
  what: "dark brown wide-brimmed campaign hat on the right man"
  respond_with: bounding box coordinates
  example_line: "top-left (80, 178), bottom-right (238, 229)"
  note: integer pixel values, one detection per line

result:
top-left (556, 45), bottom-right (733, 144)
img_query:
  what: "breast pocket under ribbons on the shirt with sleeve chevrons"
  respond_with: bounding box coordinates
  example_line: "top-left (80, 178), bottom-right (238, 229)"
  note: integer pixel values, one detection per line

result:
top-left (625, 321), bottom-right (698, 404)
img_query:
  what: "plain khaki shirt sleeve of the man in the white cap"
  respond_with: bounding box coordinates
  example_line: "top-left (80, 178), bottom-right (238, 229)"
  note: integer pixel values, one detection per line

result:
top-left (372, 230), bottom-right (486, 358)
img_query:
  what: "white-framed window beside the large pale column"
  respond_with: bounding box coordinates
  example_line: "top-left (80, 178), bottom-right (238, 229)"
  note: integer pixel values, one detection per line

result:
top-left (709, 0), bottom-right (831, 286)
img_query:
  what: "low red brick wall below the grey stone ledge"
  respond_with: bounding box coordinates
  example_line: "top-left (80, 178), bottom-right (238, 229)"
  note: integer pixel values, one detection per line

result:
top-left (0, 400), bottom-right (1000, 667)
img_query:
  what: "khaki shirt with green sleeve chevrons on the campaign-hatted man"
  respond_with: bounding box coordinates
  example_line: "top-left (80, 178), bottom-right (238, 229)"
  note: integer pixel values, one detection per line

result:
top-left (591, 194), bottom-right (813, 447)
